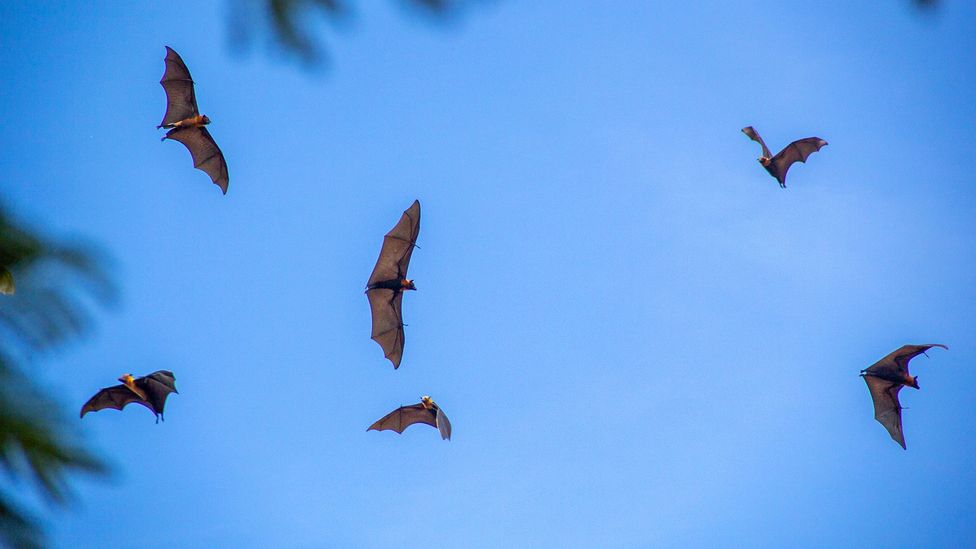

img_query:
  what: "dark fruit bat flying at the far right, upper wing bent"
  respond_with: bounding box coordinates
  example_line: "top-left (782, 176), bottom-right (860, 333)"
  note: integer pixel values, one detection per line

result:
top-left (861, 343), bottom-right (948, 450)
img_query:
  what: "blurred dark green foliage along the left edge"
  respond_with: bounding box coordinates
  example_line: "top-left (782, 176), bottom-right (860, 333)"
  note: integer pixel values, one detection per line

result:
top-left (0, 208), bottom-right (116, 547)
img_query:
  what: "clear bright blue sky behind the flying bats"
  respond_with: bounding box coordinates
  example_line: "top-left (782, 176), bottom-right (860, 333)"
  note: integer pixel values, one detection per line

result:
top-left (0, 0), bottom-right (976, 548)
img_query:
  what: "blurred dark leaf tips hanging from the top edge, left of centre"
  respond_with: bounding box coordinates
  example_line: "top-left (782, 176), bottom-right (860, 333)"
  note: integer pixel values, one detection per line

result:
top-left (230, 0), bottom-right (483, 65)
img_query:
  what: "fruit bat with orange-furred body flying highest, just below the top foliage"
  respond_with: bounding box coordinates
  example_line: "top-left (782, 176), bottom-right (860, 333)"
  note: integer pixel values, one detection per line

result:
top-left (156, 46), bottom-right (230, 194)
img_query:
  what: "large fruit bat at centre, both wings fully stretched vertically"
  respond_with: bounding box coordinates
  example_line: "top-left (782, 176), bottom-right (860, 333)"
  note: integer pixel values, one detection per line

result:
top-left (366, 200), bottom-right (420, 369)
